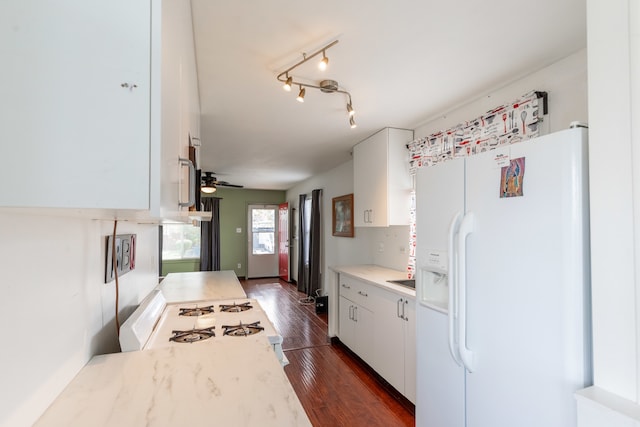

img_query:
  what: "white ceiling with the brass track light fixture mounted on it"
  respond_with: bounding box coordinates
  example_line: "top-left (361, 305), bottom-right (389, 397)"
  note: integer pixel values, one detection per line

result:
top-left (191, 0), bottom-right (586, 190)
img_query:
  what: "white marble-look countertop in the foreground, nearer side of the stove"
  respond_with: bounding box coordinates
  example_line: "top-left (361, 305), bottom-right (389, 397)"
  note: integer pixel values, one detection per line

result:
top-left (35, 337), bottom-right (311, 427)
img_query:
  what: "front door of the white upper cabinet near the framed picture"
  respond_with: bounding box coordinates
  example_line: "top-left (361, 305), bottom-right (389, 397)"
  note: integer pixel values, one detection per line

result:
top-left (353, 129), bottom-right (388, 227)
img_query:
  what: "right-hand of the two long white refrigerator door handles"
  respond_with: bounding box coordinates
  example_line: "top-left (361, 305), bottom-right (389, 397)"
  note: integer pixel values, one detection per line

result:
top-left (456, 212), bottom-right (475, 372)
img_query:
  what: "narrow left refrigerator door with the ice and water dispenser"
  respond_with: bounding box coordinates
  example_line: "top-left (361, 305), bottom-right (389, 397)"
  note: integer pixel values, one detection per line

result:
top-left (415, 159), bottom-right (465, 427)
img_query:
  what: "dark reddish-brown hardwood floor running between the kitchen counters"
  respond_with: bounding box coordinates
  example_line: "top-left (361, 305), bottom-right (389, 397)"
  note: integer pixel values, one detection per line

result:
top-left (240, 278), bottom-right (415, 427)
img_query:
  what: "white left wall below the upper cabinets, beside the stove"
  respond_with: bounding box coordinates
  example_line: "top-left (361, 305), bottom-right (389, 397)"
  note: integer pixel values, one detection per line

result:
top-left (0, 212), bottom-right (158, 427)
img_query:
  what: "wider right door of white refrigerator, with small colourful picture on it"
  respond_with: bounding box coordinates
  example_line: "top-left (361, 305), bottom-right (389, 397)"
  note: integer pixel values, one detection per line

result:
top-left (466, 129), bottom-right (590, 427)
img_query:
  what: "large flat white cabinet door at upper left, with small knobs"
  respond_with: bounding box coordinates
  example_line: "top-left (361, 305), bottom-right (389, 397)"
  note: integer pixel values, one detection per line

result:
top-left (0, 0), bottom-right (151, 209)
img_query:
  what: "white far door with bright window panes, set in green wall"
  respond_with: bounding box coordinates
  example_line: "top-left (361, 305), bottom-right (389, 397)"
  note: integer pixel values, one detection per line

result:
top-left (247, 205), bottom-right (278, 278)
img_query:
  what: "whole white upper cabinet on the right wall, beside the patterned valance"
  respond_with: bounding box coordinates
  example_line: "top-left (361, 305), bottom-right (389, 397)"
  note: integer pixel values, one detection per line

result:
top-left (353, 128), bottom-right (413, 227)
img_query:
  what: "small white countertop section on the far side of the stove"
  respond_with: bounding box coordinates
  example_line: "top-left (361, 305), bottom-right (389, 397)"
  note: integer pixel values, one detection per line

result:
top-left (157, 270), bottom-right (247, 304)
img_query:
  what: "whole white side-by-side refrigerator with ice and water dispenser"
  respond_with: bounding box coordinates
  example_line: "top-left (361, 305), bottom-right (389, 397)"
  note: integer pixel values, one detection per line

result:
top-left (416, 128), bottom-right (592, 427)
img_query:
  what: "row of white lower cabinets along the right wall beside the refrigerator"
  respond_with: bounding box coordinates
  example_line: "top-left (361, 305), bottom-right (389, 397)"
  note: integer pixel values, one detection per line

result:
top-left (338, 275), bottom-right (416, 403)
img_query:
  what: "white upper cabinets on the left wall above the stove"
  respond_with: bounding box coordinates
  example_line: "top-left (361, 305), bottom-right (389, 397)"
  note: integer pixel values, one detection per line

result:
top-left (0, 0), bottom-right (199, 224)
